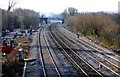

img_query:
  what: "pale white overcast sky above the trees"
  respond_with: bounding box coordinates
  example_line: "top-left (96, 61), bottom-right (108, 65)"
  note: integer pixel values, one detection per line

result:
top-left (0, 0), bottom-right (120, 13)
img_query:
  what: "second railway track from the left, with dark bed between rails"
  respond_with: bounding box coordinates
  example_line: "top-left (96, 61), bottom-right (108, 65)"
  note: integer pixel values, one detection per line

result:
top-left (50, 23), bottom-right (102, 77)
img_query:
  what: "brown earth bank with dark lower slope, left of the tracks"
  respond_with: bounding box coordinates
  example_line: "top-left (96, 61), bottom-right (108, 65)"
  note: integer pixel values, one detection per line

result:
top-left (2, 35), bottom-right (34, 77)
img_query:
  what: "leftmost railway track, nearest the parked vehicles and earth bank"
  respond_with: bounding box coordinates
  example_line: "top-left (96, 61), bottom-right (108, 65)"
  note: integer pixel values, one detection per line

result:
top-left (39, 25), bottom-right (61, 77)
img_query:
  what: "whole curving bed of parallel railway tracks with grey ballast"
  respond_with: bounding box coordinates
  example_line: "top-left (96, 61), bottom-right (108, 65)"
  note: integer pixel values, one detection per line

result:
top-left (23, 23), bottom-right (120, 77)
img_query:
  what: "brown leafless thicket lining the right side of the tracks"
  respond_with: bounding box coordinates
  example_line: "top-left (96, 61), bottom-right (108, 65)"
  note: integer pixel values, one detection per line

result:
top-left (62, 8), bottom-right (120, 51)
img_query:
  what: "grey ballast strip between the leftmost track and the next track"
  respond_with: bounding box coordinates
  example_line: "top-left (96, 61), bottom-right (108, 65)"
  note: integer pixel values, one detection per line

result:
top-left (46, 25), bottom-right (79, 77)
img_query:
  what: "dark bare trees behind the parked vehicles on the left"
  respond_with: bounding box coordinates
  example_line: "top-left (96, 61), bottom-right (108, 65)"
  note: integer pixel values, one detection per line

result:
top-left (0, 8), bottom-right (39, 30)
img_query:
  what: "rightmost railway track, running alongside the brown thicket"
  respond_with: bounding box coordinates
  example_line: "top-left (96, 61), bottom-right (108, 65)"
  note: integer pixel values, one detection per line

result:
top-left (59, 28), bottom-right (120, 62)
